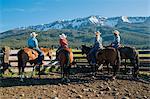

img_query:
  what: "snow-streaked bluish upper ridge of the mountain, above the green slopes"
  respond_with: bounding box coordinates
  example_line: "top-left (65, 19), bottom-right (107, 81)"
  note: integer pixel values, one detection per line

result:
top-left (18, 16), bottom-right (150, 31)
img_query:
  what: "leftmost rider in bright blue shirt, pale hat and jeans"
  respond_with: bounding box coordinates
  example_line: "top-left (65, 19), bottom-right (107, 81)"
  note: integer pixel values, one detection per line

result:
top-left (28, 32), bottom-right (44, 65)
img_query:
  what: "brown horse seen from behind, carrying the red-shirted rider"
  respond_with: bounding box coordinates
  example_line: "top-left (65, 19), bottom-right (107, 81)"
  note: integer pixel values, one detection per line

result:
top-left (58, 48), bottom-right (74, 80)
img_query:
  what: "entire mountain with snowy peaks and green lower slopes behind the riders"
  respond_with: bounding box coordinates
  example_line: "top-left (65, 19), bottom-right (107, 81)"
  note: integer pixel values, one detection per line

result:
top-left (0, 16), bottom-right (150, 49)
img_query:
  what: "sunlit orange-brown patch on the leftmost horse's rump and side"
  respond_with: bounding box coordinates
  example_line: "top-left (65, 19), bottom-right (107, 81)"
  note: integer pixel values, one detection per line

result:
top-left (23, 47), bottom-right (38, 60)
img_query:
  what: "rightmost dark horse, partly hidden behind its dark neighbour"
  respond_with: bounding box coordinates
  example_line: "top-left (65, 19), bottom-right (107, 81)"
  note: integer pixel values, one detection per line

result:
top-left (118, 46), bottom-right (139, 77)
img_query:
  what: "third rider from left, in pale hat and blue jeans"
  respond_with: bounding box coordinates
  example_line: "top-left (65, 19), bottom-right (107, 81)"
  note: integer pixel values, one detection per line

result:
top-left (89, 31), bottom-right (103, 65)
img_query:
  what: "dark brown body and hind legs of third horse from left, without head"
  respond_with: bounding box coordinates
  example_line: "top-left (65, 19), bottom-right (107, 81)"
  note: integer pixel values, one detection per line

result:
top-left (96, 47), bottom-right (121, 79)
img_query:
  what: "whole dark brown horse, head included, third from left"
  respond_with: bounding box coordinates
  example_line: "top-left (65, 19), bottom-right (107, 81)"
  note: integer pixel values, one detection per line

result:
top-left (82, 45), bottom-right (121, 79)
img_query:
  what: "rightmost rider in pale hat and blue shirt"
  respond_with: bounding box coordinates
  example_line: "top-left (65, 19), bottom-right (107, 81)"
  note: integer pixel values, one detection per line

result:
top-left (111, 30), bottom-right (120, 48)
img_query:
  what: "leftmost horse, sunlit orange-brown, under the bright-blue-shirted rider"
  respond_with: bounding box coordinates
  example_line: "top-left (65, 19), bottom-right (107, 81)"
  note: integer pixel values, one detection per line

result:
top-left (17, 47), bottom-right (52, 80)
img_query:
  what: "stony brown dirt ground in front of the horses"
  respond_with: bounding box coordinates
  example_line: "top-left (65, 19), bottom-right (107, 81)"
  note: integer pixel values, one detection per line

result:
top-left (0, 73), bottom-right (150, 99)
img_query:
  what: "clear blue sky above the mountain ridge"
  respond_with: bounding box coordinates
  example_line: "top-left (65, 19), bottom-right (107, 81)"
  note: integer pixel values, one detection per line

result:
top-left (0, 0), bottom-right (150, 32)
